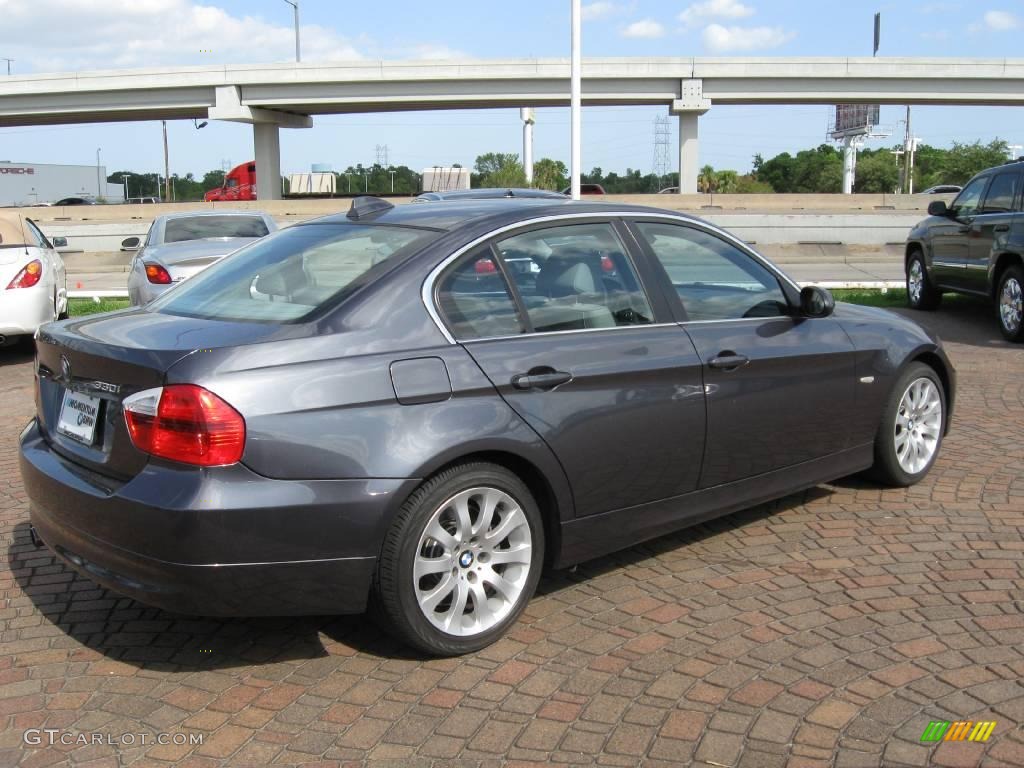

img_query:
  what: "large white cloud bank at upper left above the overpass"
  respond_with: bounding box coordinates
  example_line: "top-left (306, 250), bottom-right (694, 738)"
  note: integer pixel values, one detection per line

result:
top-left (0, 0), bottom-right (456, 72)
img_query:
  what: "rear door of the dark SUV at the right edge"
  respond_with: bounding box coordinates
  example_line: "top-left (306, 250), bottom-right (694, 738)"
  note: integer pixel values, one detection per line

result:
top-left (963, 166), bottom-right (1021, 296)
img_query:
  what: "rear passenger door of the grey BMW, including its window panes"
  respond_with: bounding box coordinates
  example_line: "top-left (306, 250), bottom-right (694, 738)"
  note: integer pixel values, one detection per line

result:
top-left (435, 217), bottom-right (706, 516)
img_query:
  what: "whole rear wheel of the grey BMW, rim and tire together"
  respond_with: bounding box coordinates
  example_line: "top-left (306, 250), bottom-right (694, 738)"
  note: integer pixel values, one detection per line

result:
top-left (375, 463), bottom-right (544, 655)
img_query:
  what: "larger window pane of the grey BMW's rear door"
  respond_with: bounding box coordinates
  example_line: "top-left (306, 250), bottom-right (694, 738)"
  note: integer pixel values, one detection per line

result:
top-left (496, 223), bottom-right (653, 333)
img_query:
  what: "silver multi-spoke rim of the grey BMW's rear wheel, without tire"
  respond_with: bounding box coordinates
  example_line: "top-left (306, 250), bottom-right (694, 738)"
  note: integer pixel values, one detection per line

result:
top-left (413, 486), bottom-right (534, 637)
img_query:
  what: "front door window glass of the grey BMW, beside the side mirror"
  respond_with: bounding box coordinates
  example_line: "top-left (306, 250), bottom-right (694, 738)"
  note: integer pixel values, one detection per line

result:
top-left (636, 222), bottom-right (790, 321)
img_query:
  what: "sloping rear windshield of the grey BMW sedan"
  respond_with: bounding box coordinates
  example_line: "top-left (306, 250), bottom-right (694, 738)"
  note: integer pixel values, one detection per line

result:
top-left (147, 224), bottom-right (437, 323)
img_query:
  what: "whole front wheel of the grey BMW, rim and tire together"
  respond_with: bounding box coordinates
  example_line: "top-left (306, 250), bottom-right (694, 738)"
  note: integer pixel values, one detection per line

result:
top-left (871, 362), bottom-right (946, 487)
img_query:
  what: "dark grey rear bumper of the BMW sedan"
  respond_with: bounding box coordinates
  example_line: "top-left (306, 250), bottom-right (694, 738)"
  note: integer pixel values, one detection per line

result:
top-left (20, 422), bottom-right (417, 615)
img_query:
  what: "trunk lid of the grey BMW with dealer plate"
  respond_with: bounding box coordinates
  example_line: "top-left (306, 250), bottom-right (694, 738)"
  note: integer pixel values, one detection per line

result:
top-left (36, 307), bottom-right (282, 480)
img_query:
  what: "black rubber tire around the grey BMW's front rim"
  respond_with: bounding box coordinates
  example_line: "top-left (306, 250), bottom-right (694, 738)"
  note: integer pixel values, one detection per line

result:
top-left (870, 362), bottom-right (947, 487)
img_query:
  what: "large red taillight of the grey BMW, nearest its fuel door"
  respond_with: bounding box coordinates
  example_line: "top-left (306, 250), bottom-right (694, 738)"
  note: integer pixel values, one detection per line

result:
top-left (122, 384), bottom-right (246, 467)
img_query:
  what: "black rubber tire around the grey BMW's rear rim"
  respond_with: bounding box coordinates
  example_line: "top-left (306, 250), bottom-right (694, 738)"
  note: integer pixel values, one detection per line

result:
top-left (372, 462), bottom-right (545, 656)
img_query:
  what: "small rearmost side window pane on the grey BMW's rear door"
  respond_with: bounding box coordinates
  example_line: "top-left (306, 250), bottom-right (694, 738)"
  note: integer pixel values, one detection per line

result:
top-left (437, 248), bottom-right (523, 339)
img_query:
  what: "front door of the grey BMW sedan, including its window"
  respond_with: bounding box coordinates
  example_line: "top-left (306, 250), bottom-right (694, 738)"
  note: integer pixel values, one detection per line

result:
top-left (631, 220), bottom-right (856, 488)
